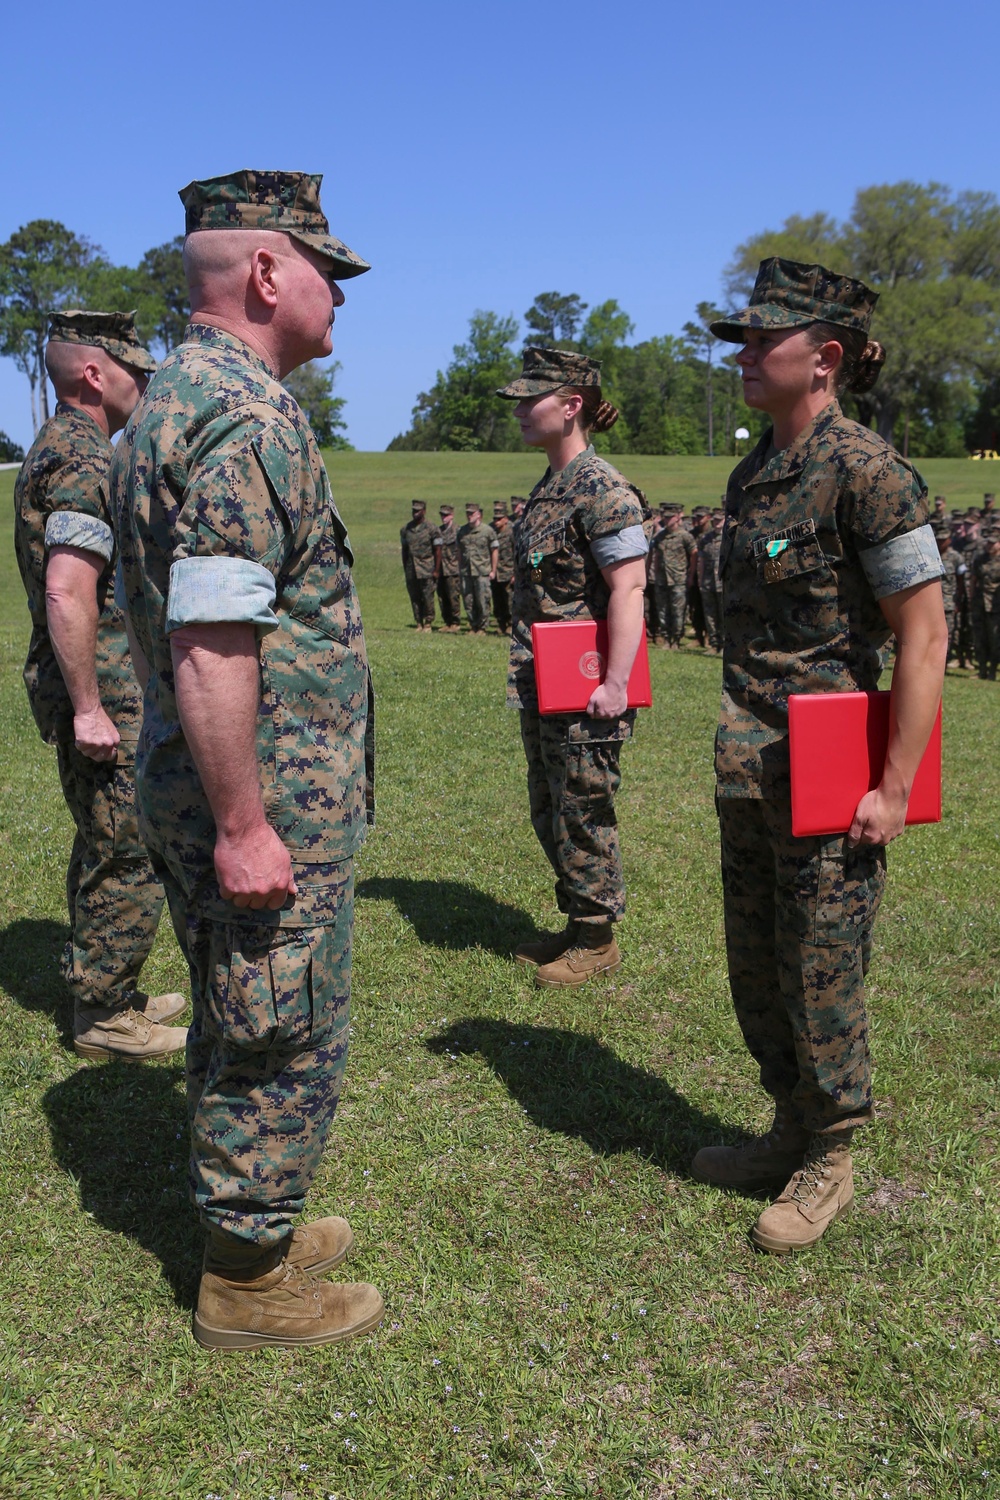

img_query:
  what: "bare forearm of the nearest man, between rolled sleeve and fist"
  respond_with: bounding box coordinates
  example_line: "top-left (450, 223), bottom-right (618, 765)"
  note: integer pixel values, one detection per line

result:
top-left (171, 624), bottom-right (265, 836)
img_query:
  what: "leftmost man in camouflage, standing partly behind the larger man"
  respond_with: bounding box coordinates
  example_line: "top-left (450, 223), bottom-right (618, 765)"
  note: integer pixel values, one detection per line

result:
top-left (13, 312), bottom-right (187, 1059)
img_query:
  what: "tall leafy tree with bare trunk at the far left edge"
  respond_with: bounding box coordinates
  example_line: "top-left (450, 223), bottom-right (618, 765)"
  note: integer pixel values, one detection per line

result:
top-left (0, 219), bottom-right (106, 432)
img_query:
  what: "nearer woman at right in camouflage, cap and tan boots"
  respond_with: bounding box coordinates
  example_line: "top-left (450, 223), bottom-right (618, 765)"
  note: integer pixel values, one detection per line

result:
top-left (693, 258), bottom-right (948, 1254)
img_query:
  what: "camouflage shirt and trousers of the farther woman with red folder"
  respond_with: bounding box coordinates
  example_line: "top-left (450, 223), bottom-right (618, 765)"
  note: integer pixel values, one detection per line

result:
top-left (507, 446), bottom-right (646, 929)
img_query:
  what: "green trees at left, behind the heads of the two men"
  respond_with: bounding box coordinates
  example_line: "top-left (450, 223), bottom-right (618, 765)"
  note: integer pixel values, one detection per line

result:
top-left (0, 219), bottom-right (351, 447)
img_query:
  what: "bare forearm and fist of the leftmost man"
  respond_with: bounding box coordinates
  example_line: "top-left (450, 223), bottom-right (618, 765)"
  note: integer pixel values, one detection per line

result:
top-left (45, 546), bottom-right (120, 761)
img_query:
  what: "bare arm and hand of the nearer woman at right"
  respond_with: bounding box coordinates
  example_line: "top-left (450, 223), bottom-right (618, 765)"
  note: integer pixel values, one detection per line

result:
top-left (847, 579), bottom-right (948, 848)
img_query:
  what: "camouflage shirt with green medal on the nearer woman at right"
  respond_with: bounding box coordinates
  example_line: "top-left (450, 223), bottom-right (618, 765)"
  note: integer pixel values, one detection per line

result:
top-left (715, 402), bottom-right (942, 798)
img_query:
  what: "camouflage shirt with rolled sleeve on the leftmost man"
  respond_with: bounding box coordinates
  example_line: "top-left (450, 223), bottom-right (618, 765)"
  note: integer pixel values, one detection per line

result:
top-left (13, 402), bottom-right (142, 744)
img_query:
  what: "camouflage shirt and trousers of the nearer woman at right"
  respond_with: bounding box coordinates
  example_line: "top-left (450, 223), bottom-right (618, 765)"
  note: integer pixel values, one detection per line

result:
top-left (715, 402), bottom-right (942, 1133)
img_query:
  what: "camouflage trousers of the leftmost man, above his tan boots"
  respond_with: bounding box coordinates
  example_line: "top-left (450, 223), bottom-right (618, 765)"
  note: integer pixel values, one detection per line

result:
top-left (55, 740), bottom-right (163, 1007)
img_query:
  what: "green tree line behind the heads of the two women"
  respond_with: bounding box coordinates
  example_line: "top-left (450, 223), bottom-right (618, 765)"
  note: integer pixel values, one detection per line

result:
top-left (390, 182), bottom-right (1000, 458)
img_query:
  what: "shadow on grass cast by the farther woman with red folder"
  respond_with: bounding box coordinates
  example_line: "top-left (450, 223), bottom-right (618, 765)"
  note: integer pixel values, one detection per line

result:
top-left (355, 876), bottom-right (538, 957)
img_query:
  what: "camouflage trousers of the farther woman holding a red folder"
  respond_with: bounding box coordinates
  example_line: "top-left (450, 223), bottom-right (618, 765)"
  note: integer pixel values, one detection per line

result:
top-left (520, 708), bottom-right (634, 924)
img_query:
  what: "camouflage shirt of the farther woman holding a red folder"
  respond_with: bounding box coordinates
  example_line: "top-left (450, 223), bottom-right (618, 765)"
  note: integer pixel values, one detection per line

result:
top-left (507, 447), bottom-right (645, 708)
